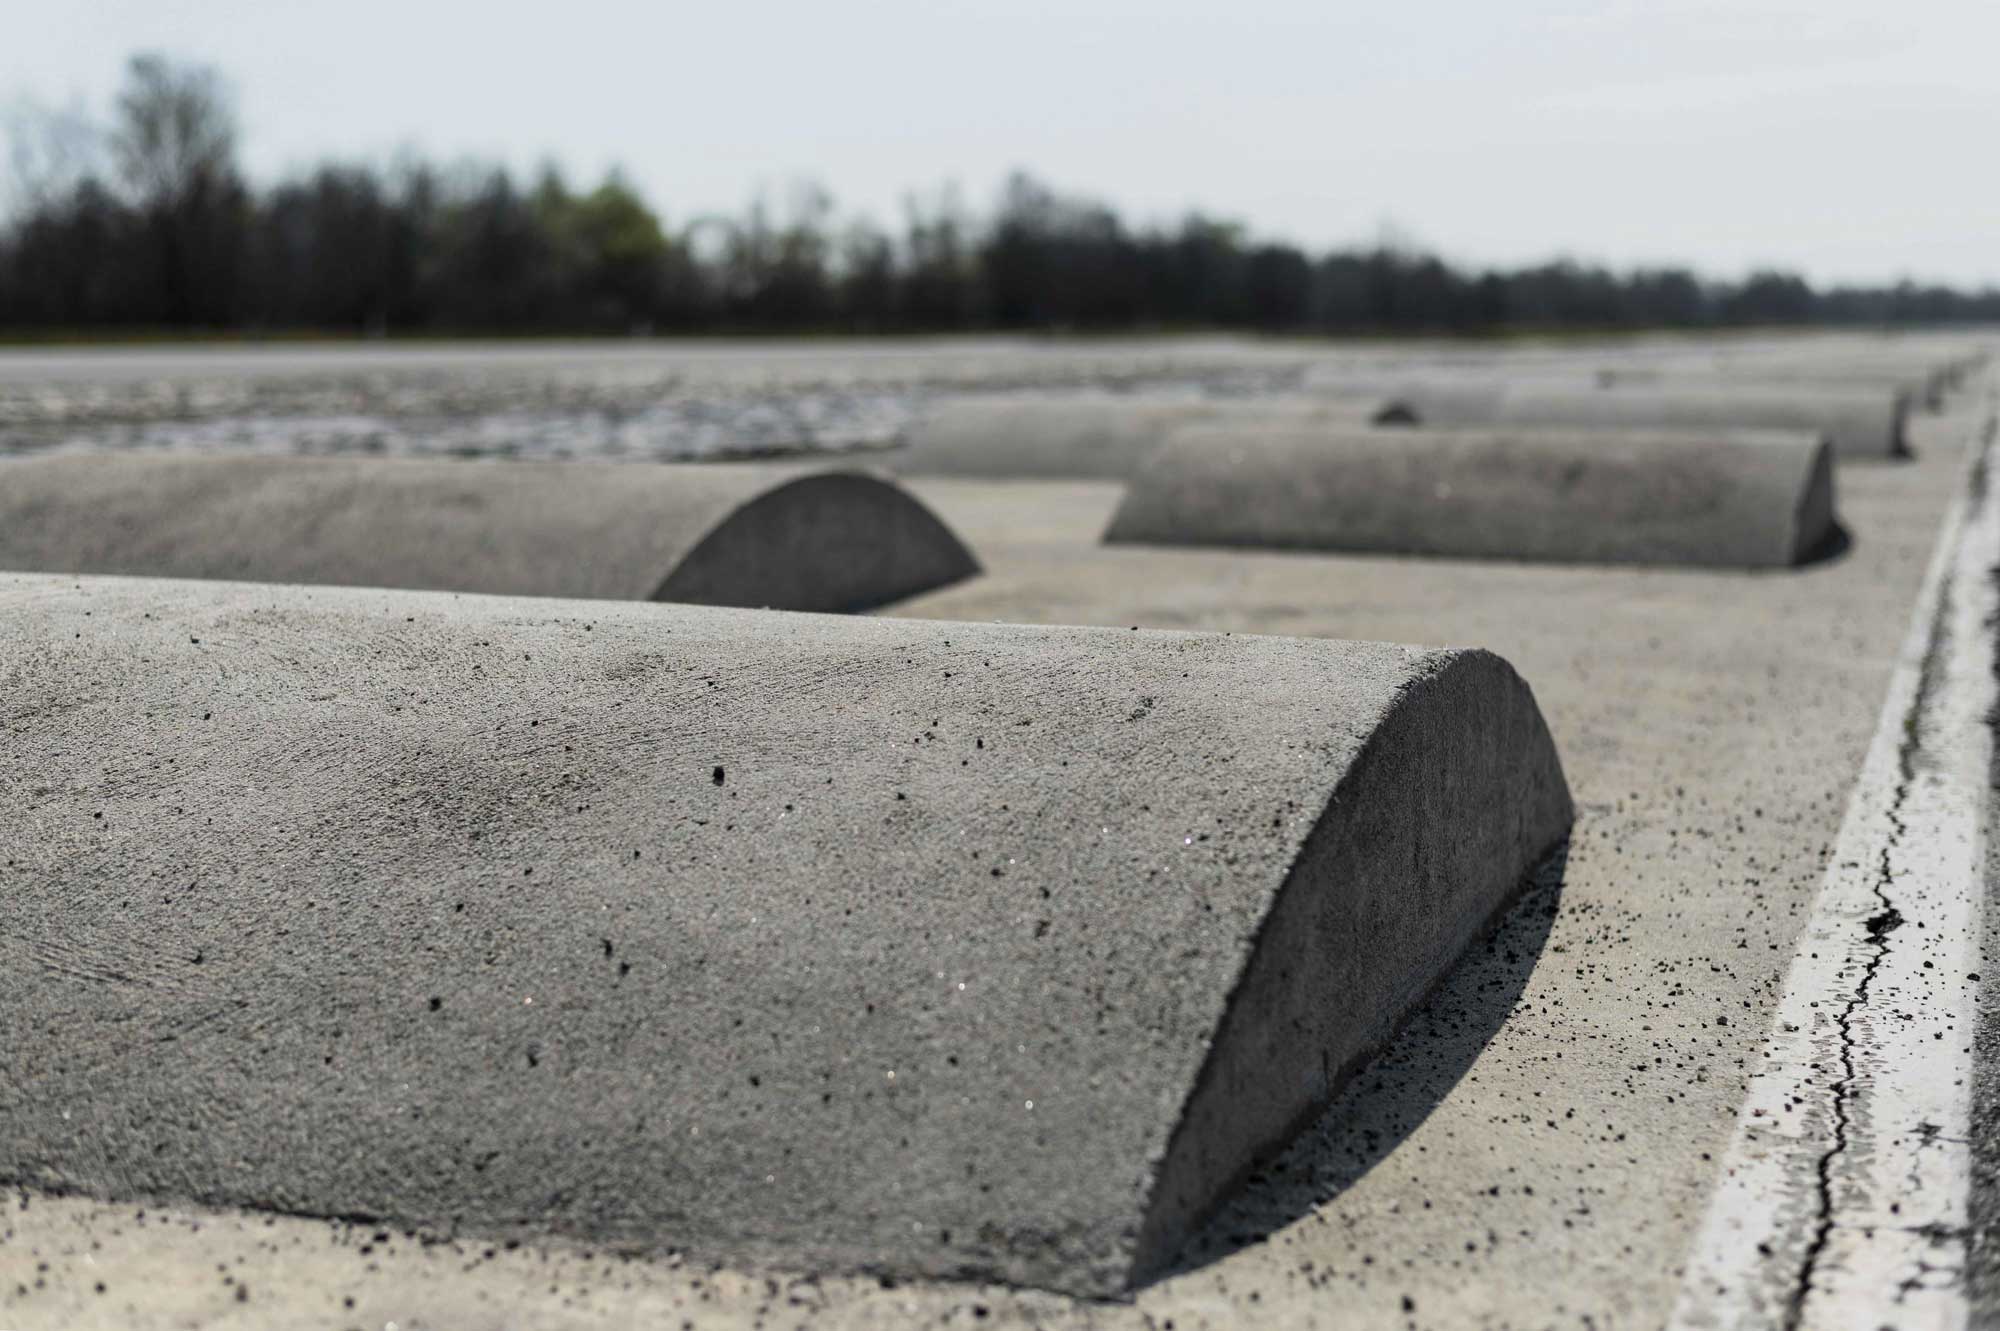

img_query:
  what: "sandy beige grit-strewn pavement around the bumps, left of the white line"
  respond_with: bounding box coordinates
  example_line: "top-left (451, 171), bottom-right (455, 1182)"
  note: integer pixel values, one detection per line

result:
top-left (0, 333), bottom-right (1994, 1331)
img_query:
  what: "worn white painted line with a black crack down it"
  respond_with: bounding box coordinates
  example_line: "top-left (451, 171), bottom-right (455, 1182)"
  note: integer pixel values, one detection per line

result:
top-left (1668, 409), bottom-right (2000, 1331)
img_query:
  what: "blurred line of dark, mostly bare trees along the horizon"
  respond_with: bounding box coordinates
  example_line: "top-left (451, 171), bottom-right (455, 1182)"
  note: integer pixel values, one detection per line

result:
top-left (0, 56), bottom-right (2000, 334)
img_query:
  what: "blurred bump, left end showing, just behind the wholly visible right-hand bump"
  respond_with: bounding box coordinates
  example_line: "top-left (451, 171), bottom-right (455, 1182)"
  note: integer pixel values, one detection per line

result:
top-left (892, 394), bottom-right (1406, 480)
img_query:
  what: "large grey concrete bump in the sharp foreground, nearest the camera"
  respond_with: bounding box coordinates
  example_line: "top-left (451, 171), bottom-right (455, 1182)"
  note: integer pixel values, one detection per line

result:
top-left (0, 576), bottom-right (1570, 1295)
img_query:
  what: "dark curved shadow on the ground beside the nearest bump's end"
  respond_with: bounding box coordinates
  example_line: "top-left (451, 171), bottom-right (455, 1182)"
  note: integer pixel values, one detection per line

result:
top-left (1156, 843), bottom-right (1568, 1279)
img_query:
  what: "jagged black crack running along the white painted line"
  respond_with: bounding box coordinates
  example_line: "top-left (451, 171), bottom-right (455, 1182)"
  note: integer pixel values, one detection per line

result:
top-left (1784, 563), bottom-right (1952, 1331)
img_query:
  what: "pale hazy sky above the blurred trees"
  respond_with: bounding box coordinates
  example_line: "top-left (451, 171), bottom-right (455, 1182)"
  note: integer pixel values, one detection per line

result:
top-left (15, 0), bottom-right (2000, 282)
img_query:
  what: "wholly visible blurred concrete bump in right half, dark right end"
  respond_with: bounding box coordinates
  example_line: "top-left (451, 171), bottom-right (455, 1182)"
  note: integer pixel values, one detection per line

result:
top-left (1104, 426), bottom-right (1836, 568)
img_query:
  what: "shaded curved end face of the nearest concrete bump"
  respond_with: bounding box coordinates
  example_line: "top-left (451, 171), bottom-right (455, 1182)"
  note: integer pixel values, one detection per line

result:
top-left (1132, 652), bottom-right (1574, 1281)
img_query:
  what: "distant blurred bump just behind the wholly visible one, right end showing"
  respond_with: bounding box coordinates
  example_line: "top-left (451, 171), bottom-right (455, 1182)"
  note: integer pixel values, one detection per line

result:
top-left (1398, 382), bottom-right (1908, 458)
